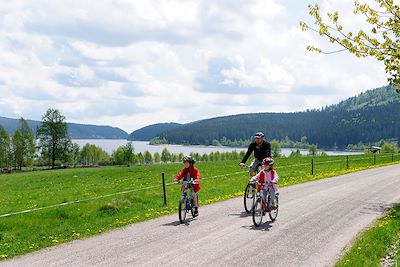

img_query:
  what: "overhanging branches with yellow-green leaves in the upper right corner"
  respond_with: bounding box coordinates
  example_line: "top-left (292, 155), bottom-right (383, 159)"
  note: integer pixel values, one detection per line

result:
top-left (300, 0), bottom-right (400, 89)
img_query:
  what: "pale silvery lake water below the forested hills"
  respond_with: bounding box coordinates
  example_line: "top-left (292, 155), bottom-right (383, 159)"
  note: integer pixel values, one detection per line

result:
top-left (72, 139), bottom-right (362, 156)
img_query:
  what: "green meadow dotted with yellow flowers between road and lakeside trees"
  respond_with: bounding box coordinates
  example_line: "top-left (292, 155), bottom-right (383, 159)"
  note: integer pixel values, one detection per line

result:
top-left (0, 154), bottom-right (400, 260)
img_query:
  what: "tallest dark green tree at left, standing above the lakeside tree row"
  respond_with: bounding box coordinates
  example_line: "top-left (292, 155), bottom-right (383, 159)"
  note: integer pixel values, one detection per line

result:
top-left (37, 109), bottom-right (71, 168)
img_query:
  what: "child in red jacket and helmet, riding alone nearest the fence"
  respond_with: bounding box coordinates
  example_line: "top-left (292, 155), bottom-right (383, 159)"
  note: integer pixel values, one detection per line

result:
top-left (174, 156), bottom-right (201, 217)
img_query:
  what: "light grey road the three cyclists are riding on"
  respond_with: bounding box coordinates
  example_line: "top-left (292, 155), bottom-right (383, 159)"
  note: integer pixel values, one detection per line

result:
top-left (0, 165), bottom-right (400, 266)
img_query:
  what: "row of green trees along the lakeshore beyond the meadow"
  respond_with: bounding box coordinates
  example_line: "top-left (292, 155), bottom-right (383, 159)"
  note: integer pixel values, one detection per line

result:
top-left (0, 105), bottom-right (398, 173)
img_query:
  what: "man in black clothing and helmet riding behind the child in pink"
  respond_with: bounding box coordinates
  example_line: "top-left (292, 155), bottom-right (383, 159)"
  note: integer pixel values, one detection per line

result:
top-left (239, 132), bottom-right (271, 176)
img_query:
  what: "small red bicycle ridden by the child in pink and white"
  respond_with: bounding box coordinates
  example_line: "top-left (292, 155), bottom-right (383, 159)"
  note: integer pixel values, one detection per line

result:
top-left (252, 182), bottom-right (279, 227)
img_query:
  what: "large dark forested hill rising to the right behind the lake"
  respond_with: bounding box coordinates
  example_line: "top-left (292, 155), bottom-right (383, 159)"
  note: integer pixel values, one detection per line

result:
top-left (154, 87), bottom-right (400, 149)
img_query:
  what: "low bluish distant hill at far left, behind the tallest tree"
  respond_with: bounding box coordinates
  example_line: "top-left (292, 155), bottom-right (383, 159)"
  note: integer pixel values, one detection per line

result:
top-left (0, 117), bottom-right (128, 139)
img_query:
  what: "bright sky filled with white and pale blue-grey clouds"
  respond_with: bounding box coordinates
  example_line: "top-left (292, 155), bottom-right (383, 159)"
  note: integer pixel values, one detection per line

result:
top-left (0, 0), bottom-right (388, 133)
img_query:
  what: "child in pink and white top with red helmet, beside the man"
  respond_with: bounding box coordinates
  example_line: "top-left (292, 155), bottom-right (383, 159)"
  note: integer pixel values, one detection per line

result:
top-left (251, 157), bottom-right (279, 208)
